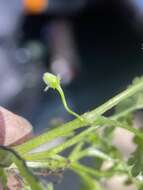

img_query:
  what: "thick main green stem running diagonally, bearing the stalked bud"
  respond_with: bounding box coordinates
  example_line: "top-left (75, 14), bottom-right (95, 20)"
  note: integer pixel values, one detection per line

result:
top-left (14, 78), bottom-right (143, 154)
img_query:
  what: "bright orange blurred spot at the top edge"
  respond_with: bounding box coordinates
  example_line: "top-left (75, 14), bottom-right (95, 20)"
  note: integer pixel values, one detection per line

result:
top-left (23, 0), bottom-right (48, 14)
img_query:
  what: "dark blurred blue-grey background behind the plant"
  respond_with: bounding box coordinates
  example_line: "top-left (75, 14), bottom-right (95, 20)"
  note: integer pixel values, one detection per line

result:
top-left (0, 0), bottom-right (143, 189)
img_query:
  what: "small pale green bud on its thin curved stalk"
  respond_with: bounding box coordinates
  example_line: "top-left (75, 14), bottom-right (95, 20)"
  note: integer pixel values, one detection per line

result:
top-left (43, 72), bottom-right (84, 121)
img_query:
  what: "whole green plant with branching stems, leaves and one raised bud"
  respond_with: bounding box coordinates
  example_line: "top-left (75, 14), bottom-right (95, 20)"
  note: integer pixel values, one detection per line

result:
top-left (0, 73), bottom-right (143, 190)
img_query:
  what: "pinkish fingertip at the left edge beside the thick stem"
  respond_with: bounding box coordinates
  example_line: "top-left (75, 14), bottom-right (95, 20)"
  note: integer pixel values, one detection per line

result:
top-left (0, 106), bottom-right (32, 146)
